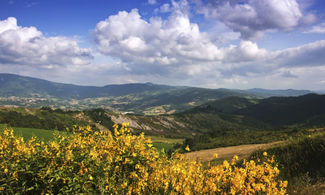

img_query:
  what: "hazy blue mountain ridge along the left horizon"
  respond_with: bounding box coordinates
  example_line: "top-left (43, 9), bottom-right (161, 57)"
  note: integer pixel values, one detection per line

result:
top-left (0, 74), bottom-right (176, 99)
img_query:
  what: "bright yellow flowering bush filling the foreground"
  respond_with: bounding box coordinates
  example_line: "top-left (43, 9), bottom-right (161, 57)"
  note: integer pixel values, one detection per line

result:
top-left (0, 124), bottom-right (287, 194)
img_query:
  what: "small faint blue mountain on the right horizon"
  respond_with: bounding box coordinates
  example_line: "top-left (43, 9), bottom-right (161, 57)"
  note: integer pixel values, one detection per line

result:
top-left (239, 88), bottom-right (313, 98)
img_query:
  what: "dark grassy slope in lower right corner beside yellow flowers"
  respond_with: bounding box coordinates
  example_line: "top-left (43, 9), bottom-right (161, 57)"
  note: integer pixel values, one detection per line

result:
top-left (249, 131), bottom-right (325, 194)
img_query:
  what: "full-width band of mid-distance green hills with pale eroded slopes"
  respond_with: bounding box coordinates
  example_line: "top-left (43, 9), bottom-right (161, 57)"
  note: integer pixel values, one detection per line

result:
top-left (0, 94), bottom-right (325, 153)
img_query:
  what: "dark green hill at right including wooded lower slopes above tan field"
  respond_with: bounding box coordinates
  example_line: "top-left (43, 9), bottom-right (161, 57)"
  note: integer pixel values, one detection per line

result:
top-left (176, 94), bottom-right (325, 150)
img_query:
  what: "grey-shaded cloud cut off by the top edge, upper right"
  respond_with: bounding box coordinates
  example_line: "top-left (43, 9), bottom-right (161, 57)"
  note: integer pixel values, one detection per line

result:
top-left (197, 0), bottom-right (316, 39)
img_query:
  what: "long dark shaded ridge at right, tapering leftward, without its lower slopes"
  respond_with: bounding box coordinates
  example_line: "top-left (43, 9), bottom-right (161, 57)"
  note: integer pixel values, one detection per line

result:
top-left (184, 94), bottom-right (325, 128)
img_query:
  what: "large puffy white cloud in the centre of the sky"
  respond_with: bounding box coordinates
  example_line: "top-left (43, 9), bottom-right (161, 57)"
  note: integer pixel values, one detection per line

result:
top-left (94, 9), bottom-right (223, 71)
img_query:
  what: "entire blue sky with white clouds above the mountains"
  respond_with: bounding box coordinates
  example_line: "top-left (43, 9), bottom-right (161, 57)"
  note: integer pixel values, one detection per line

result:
top-left (0, 0), bottom-right (325, 90)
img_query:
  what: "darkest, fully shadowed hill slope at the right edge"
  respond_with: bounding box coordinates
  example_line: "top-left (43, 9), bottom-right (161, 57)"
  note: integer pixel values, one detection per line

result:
top-left (234, 94), bottom-right (325, 126)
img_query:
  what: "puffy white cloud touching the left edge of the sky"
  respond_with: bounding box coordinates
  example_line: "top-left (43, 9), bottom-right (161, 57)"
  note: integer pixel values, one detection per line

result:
top-left (0, 17), bottom-right (92, 69)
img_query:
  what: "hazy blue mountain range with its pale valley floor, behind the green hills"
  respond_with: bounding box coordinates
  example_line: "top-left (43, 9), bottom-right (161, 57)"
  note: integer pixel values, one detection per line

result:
top-left (0, 73), bottom-right (312, 112)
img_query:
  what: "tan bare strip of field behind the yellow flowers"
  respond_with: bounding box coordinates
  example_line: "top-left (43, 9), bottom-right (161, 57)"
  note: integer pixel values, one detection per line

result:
top-left (185, 141), bottom-right (283, 162)
